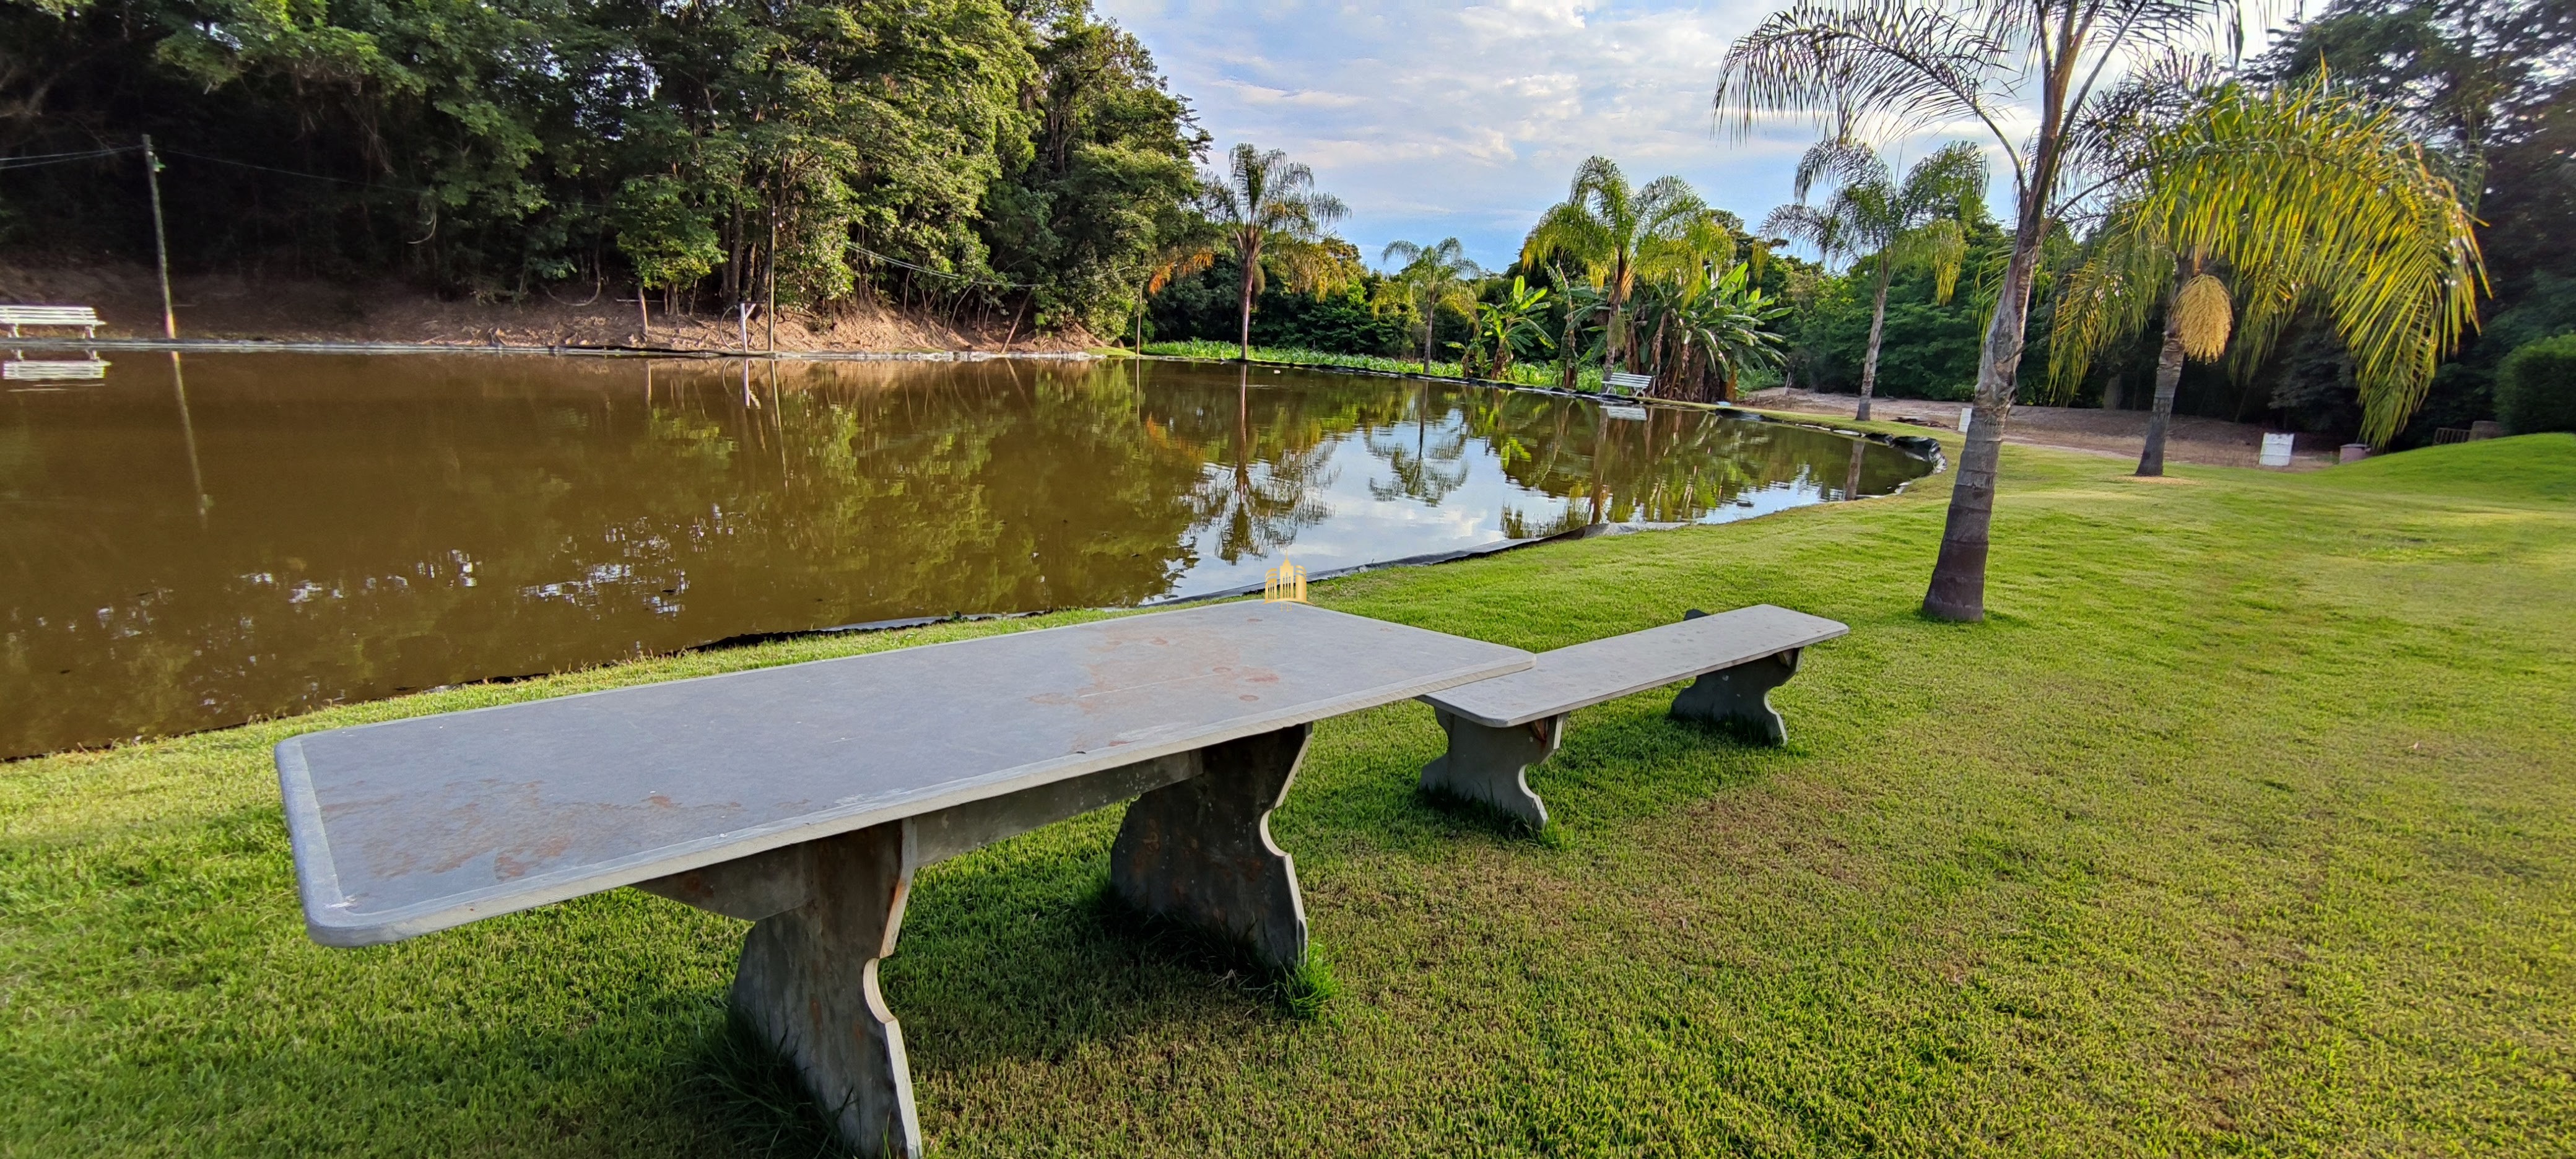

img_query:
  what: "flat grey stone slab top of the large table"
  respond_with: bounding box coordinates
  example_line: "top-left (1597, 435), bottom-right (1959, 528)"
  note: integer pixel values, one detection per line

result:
top-left (276, 602), bottom-right (1530, 945)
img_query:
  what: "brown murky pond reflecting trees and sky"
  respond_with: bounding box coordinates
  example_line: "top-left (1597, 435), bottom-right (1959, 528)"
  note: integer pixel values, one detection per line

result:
top-left (0, 353), bottom-right (1932, 755)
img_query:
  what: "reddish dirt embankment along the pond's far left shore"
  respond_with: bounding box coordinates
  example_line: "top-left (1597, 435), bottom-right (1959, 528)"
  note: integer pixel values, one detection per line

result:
top-left (0, 263), bottom-right (1092, 350)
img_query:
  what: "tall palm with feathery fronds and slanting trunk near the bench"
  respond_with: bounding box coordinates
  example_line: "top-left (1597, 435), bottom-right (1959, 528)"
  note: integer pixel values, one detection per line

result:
top-left (1716, 0), bottom-right (2297, 621)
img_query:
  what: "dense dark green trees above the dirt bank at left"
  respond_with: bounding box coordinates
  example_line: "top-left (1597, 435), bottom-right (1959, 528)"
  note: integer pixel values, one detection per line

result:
top-left (0, 0), bottom-right (1206, 329)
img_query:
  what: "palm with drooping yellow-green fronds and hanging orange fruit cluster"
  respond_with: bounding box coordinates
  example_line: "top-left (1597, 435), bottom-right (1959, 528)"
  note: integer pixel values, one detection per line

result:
top-left (2048, 85), bottom-right (2483, 477)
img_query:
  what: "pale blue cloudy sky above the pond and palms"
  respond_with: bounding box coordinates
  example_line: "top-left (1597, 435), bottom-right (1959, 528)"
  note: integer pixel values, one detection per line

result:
top-left (1095, 0), bottom-right (2297, 268)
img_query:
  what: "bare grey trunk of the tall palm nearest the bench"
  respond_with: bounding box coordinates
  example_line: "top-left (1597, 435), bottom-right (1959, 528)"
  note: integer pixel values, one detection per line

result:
top-left (1925, 206), bottom-right (2048, 621)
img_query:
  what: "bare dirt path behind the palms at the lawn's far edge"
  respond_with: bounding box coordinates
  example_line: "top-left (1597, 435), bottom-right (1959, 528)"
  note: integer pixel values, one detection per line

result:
top-left (1744, 389), bottom-right (2339, 471)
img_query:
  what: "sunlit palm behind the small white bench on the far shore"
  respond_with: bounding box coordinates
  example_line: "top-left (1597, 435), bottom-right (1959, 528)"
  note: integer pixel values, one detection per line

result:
top-left (1520, 157), bottom-right (1713, 389)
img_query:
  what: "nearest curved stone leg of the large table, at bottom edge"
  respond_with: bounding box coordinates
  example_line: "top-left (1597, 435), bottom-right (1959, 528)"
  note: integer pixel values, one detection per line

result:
top-left (734, 822), bottom-right (922, 1159)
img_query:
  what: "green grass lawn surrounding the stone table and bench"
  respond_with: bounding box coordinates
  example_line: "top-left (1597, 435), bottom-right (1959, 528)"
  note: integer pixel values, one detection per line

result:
top-left (0, 428), bottom-right (2576, 1157)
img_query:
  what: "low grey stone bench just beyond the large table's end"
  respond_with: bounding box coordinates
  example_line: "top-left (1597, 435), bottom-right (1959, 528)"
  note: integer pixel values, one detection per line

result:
top-left (1419, 602), bottom-right (1852, 830)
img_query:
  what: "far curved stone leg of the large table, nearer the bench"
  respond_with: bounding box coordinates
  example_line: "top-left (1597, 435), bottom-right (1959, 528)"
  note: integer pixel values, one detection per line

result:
top-left (1110, 724), bottom-right (1311, 968)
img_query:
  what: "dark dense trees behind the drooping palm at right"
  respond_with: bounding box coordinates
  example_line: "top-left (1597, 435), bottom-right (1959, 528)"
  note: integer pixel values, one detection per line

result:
top-left (1788, 0), bottom-right (2576, 446)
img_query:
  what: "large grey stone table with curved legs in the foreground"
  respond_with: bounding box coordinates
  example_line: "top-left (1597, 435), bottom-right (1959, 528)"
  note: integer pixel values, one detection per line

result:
top-left (276, 602), bottom-right (1525, 1157)
